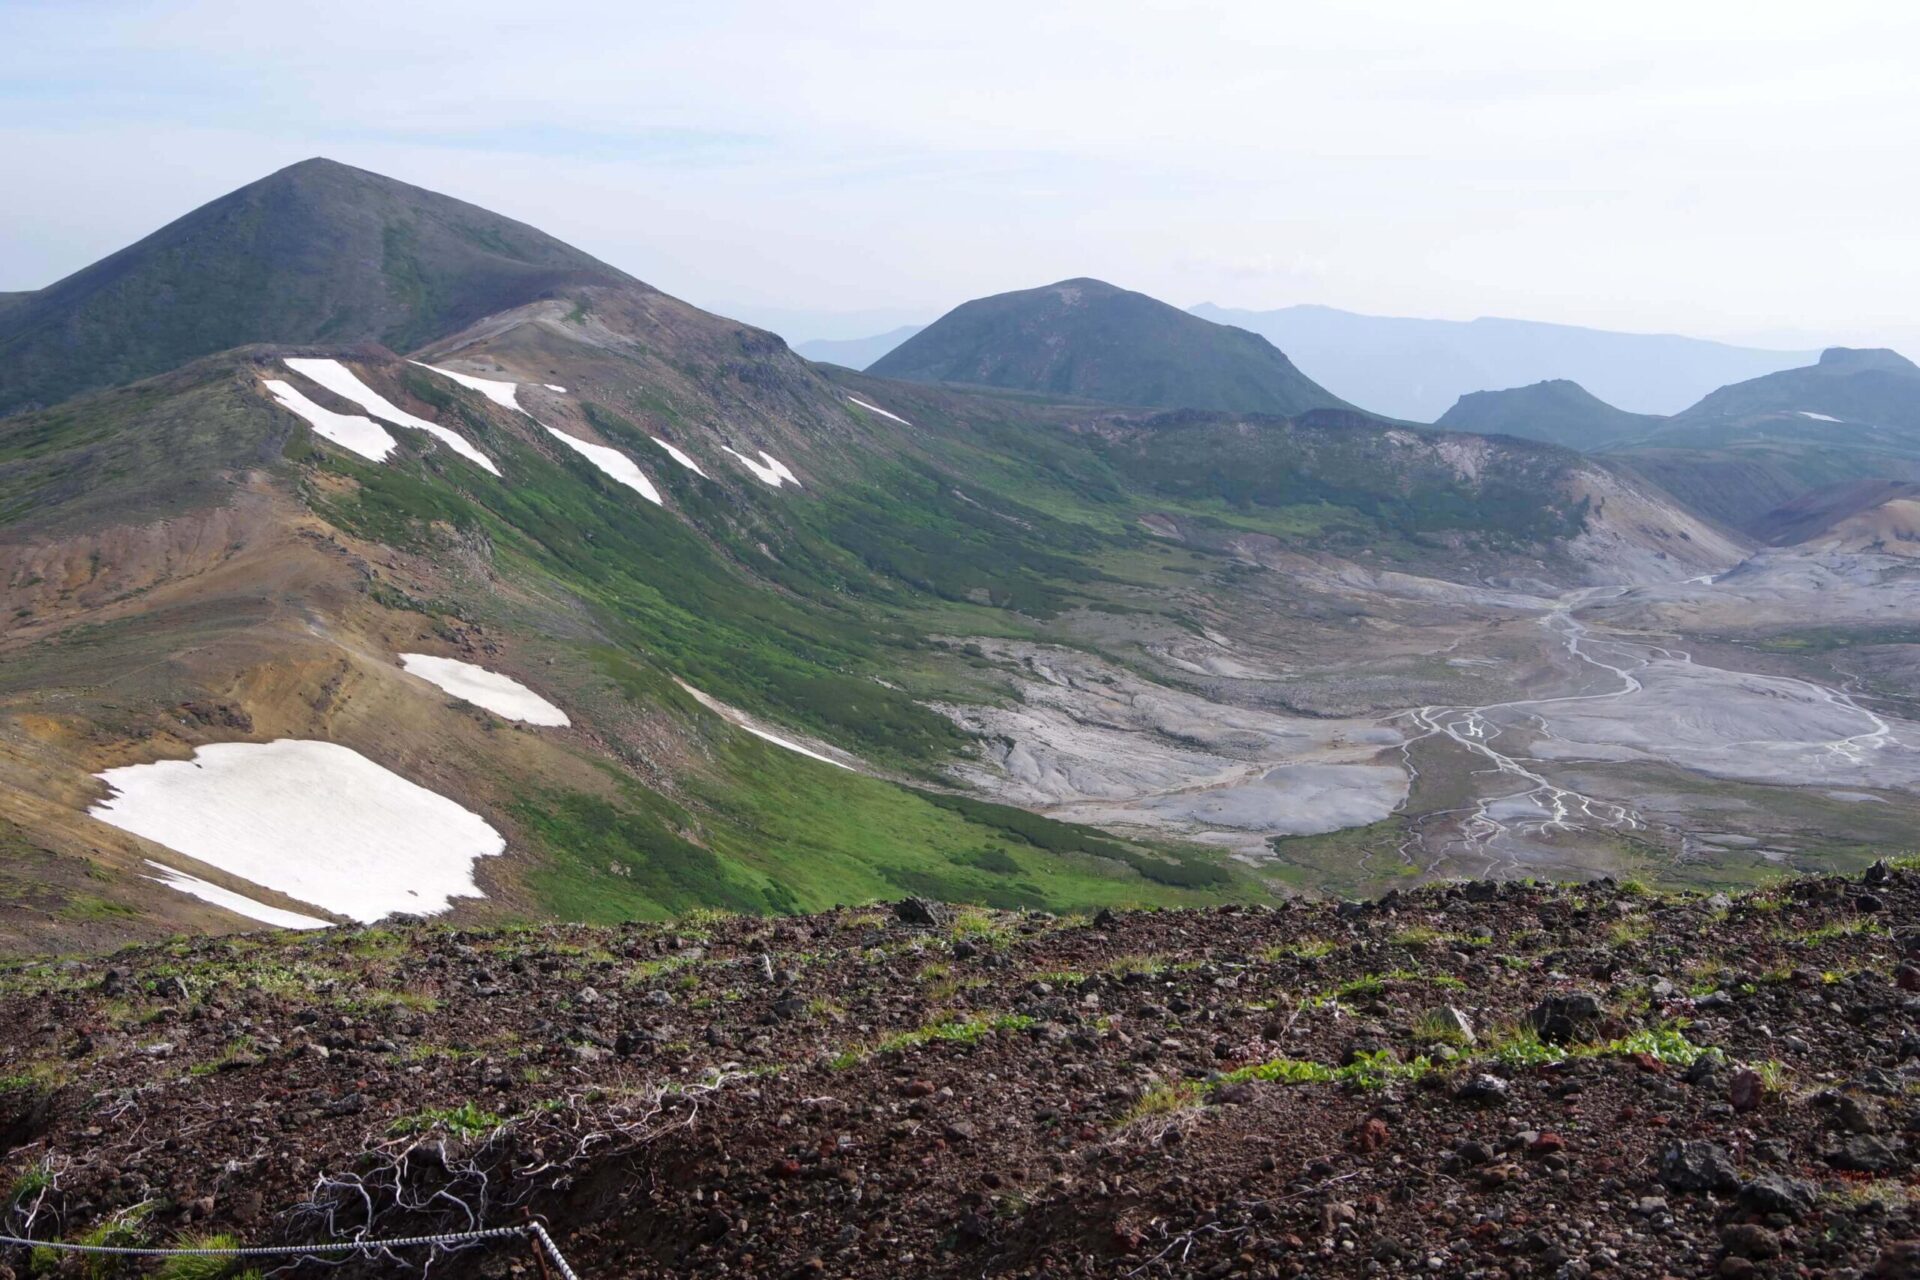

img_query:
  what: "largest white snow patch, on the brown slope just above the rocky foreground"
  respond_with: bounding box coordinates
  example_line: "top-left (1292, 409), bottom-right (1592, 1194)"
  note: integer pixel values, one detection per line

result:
top-left (88, 739), bottom-right (507, 923)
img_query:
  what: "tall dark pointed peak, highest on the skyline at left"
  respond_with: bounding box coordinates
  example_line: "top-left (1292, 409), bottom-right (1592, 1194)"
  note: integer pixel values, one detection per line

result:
top-left (0, 159), bottom-right (637, 415)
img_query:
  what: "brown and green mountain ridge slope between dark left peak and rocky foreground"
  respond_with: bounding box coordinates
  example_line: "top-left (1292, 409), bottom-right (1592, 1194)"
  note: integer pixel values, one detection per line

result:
top-left (0, 165), bottom-right (1728, 946)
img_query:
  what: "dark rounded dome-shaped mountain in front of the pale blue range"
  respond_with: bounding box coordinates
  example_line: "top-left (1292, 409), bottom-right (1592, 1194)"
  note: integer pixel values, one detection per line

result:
top-left (868, 280), bottom-right (1350, 416)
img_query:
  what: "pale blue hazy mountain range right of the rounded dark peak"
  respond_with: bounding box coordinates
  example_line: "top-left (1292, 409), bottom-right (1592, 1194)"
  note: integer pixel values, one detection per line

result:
top-left (1192, 303), bottom-right (1814, 422)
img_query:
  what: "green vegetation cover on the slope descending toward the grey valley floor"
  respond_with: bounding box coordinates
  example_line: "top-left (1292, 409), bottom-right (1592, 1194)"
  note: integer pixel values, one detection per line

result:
top-left (0, 345), bottom-right (1635, 936)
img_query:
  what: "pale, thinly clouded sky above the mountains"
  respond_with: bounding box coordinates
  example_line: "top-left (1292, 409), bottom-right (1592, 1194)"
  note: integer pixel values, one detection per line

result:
top-left (0, 0), bottom-right (1920, 353)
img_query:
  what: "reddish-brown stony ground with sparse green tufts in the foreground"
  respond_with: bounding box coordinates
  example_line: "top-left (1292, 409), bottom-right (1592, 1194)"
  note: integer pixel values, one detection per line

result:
top-left (0, 865), bottom-right (1920, 1278)
